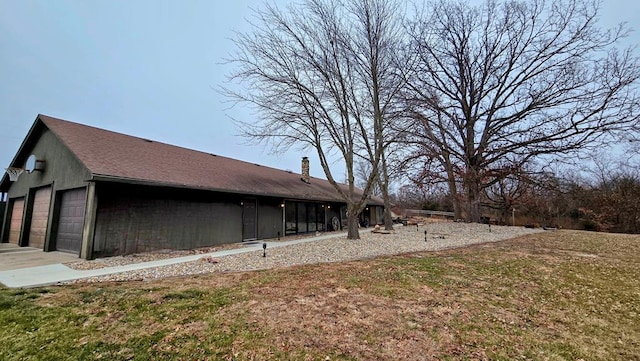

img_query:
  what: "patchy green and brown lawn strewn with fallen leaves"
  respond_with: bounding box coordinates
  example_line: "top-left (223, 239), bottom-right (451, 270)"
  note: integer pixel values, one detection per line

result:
top-left (0, 231), bottom-right (640, 360)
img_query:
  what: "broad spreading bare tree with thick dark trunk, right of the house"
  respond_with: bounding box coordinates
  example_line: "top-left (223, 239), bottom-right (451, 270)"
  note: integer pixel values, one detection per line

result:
top-left (407, 0), bottom-right (640, 221)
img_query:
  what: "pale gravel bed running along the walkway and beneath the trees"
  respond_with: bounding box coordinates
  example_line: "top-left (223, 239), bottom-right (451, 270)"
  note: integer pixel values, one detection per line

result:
top-left (67, 222), bottom-right (543, 283)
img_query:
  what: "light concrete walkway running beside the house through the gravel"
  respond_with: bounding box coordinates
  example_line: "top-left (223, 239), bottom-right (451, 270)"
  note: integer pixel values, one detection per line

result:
top-left (0, 233), bottom-right (347, 288)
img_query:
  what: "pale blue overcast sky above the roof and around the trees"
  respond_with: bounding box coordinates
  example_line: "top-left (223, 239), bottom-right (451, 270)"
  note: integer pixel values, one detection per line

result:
top-left (0, 0), bottom-right (640, 179)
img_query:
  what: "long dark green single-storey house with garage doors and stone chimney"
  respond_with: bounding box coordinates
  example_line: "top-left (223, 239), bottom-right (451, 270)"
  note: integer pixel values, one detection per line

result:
top-left (0, 115), bottom-right (383, 259)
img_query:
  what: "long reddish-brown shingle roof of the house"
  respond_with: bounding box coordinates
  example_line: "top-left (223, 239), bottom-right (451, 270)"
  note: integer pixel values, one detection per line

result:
top-left (38, 115), bottom-right (381, 204)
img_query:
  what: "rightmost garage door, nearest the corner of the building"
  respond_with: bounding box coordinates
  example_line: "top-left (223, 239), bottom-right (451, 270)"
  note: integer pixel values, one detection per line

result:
top-left (56, 188), bottom-right (86, 253)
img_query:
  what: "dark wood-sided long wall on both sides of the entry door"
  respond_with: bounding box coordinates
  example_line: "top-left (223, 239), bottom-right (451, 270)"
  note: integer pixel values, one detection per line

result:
top-left (92, 183), bottom-right (282, 257)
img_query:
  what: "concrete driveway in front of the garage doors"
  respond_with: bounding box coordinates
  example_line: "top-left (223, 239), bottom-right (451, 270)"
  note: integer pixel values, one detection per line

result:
top-left (0, 243), bottom-right (79, 271)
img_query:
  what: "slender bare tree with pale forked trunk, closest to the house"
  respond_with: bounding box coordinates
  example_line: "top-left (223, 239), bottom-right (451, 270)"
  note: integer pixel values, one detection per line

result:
top-left (224, 0), bottom-right (402, 239)
